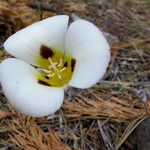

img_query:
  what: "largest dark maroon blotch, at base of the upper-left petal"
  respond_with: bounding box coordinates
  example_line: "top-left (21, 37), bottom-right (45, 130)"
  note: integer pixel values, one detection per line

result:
top-left (40, 45), bottom-right (54, 59)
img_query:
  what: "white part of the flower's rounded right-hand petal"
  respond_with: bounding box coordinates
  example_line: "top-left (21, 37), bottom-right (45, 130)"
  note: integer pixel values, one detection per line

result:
top-left (65, 19), bottom-right (110, 88)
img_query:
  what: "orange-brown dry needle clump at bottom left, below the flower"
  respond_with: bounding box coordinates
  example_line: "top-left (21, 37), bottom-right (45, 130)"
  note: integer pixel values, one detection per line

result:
top-left (5, 114), bottom-right (70, 150)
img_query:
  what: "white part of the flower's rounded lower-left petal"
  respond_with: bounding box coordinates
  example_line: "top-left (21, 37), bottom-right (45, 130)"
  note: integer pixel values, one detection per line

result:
top-left (0, 58), bottom-right (64, 117)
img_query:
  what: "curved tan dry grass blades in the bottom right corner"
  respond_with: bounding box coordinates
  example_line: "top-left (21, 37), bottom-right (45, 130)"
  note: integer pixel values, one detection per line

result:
top-left (115, 116), bottom-right (148, 150)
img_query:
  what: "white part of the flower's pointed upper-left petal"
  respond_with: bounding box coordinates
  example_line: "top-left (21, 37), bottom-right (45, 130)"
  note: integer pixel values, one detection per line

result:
top-left (4, 15), bottom-right (69, 64)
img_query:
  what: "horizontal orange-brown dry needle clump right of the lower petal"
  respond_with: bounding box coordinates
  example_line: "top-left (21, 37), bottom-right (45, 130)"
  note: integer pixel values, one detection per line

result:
top-left (63, 92), bottom-right (150, 121)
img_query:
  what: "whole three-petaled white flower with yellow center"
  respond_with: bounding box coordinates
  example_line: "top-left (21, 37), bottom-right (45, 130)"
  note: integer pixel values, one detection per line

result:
top-left (0, 15), bottom-right (110, 117)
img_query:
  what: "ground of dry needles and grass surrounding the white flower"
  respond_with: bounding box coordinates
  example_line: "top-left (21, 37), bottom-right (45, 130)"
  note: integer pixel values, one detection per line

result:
top-left (0, 0), bottom-right (150, 150)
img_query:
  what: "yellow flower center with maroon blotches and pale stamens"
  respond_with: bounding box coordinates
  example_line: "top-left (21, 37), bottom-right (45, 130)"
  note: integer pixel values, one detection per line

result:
top-left (37, 45), bottom-right (76, 87)
